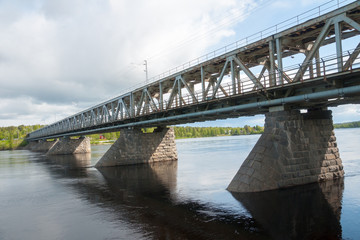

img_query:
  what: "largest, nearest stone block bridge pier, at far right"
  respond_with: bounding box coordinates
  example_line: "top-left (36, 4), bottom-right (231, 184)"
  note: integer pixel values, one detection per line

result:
top-left (227, 110), bottom-right (344, 192)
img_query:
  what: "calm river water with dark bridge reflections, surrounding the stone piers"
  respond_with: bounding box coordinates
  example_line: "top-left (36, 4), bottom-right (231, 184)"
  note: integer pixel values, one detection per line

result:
top-left (0, 129), bottom-right (360, 240)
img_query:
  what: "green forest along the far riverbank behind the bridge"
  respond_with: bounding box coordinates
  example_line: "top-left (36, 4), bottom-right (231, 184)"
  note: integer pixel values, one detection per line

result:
top-left (0, 121), bottom-right (360, 150)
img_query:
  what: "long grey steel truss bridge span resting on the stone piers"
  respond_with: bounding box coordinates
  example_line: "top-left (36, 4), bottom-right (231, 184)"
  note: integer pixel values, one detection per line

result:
top-left (27, 1), bottom-right (360, 141)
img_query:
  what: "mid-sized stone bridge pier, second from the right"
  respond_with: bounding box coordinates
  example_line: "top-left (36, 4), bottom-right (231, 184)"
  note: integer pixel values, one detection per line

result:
top-left (95, 128), bottom-right (177, 168)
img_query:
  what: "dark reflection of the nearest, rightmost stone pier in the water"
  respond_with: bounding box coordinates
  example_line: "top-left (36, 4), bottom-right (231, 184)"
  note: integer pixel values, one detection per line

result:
top-left (232, 179), bottom-right (344, 239)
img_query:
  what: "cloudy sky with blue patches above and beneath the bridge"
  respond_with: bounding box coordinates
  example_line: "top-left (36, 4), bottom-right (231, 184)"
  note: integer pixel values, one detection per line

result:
top-left (0, 0), bottom-right (360, 127)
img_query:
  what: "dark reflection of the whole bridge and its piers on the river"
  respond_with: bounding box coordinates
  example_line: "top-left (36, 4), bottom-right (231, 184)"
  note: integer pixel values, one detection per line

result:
top-left (44, 154), bottom-right (344, 239)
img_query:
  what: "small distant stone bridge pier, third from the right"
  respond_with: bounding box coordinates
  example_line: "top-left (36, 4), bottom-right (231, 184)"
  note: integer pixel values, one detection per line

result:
top-left (47, 137), bottom-right (91, 155)
